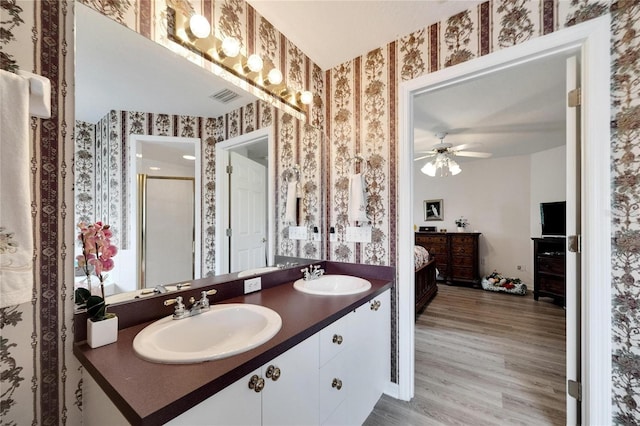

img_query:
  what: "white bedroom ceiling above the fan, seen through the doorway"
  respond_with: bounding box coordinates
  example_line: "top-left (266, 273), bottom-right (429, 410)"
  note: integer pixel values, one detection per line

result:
top-left (414, 52), bottom-right (570, 164)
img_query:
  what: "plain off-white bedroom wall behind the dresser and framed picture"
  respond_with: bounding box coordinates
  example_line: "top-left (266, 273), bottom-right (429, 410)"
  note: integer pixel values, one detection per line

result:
top-left (413, 146), bottom-right (567, 289)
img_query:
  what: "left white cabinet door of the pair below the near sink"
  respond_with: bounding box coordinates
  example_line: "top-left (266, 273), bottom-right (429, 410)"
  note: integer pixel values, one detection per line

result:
top-left (166, 369), bottom-right (262, 426)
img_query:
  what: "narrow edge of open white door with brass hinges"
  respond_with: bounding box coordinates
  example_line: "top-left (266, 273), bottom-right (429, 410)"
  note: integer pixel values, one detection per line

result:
top-left (565, 56), bottom-right (582, 425)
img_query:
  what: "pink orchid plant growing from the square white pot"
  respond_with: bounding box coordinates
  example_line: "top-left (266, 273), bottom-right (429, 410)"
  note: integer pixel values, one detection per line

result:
top-left (76, 222), bottom-right (118, 319)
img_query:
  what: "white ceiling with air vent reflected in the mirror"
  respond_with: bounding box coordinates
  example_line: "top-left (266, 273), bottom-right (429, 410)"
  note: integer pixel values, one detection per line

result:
top-left (75, 2), bottom-right (256, 123)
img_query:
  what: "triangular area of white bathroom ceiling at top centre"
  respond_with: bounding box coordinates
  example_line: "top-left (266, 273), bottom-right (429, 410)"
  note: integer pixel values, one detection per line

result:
top-left (247, 0), bottom-right (482, 70)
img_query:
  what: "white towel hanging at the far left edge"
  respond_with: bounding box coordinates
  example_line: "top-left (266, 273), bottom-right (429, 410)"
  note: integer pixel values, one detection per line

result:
top-left (0, 70), bottom-right (33, 308)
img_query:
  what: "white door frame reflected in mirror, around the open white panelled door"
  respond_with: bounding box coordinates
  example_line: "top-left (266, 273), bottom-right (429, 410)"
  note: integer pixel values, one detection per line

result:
top-left (215, 126), bottom-right (276, 275)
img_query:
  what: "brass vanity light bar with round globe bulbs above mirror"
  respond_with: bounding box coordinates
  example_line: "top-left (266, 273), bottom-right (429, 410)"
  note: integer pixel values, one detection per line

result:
top-left (167, 7), bottom-right (313, 114)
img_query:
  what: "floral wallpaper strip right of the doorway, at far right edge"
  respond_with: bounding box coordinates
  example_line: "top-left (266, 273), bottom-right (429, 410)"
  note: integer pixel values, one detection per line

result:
top-left (608, 1), bottom-right (640, 424)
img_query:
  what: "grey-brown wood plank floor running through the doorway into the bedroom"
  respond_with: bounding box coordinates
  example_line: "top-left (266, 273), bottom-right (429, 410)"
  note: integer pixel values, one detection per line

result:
top-left (365, 285), bottom-right (565, 426)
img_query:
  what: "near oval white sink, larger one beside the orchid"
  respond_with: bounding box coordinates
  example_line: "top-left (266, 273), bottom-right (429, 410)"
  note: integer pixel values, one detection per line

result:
top-left (133, 303), bottom-right (282, 364)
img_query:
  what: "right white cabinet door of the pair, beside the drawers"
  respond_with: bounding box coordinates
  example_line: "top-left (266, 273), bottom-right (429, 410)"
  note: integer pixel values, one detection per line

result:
top-left (261, 334), bottom-right (320, 426)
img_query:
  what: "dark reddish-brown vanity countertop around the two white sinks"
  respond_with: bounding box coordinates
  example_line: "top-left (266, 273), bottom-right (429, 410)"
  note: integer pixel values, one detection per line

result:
top-left (74, 262), bottom-right (395, 425)
